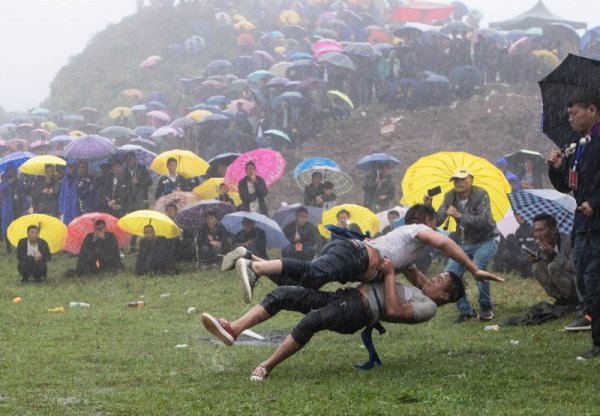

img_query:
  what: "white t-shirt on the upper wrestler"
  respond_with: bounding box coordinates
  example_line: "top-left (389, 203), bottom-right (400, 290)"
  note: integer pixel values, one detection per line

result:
top-left (366, 224), bottom-right (431, 270)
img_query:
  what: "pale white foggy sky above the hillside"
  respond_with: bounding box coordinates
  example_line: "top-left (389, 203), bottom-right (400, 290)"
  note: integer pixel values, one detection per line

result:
top-left (0, 0), bottom-right (600, 111)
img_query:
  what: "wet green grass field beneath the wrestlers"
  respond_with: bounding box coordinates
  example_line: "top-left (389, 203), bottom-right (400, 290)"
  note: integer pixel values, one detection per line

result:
top-left (0, 255), bottom-right (600, 415)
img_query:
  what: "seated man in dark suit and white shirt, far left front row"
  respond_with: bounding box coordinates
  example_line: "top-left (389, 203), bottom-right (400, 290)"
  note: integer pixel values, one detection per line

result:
top-left (17, 225), bottom-right (52, 283)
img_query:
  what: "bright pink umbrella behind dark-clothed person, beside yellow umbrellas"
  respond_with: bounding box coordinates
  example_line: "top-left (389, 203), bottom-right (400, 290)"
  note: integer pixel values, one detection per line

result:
top-left (225, 149), bottom-right (285, 192)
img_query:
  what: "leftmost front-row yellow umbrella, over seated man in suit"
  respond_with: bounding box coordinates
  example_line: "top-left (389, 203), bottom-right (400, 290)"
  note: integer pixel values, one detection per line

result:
top-left (6, 214), bottom-right (67, 253)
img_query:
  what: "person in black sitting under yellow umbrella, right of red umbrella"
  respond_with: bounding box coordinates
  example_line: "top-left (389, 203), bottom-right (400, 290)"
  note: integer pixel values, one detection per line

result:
top-left (135, 225), bottom-right (175, 276)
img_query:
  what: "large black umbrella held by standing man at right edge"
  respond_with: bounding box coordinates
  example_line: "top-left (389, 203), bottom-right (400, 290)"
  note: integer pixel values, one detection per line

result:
top-left (539, 54), bottom-right (600, 148)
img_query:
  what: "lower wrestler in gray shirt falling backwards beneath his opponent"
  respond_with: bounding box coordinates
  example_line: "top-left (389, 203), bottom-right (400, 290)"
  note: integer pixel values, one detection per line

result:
top-left (201, 258), bottom-right (464, 381)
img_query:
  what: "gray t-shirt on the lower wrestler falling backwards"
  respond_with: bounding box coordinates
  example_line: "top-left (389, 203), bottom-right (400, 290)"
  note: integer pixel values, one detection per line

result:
top-left (367, 282), bottom-right (437, 324)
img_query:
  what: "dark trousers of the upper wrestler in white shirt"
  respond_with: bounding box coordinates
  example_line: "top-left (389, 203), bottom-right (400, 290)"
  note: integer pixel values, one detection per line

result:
top-left (268, 239), bottom-right (369, 289)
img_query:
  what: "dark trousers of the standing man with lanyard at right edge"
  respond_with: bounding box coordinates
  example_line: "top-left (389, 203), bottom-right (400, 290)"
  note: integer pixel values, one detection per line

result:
top-left (573, 230), bottom-right (600, 347)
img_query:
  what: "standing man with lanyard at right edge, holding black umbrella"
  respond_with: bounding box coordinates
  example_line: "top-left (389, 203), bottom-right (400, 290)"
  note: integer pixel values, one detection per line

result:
top-left (547, 90), bottom-right (600, 359)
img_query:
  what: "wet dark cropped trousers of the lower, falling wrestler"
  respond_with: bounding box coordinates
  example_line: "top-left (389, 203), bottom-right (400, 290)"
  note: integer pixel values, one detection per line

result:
top-left (260, 286), bottom-right (370, 346)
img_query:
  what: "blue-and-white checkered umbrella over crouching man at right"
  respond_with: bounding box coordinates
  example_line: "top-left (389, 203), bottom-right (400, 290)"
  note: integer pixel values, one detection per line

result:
top-left (508, 189), bottom-right (577, 234)
